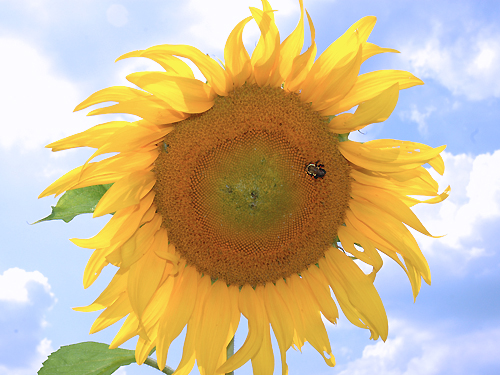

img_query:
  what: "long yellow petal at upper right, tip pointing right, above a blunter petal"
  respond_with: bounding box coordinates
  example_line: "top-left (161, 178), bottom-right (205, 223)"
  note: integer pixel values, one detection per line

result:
top-left (320, 70), bottom-right (424, 116)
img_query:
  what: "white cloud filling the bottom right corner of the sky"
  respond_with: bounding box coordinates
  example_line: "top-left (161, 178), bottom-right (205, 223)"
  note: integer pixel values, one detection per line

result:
top-left (339, 319), bottom-right (500, 375)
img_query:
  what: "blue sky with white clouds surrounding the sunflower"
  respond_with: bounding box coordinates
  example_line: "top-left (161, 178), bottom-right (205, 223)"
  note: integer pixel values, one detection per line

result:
top-left (0, 0), bottom-right (500, 375)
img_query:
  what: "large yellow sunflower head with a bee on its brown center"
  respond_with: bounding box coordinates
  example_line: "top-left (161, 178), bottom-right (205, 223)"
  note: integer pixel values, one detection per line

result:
top-left (41, 0), bottom-right (449, 375)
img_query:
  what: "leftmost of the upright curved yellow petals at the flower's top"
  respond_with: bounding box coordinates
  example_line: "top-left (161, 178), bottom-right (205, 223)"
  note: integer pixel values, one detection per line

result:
top-left (224, 17), bottom-right (252, 88)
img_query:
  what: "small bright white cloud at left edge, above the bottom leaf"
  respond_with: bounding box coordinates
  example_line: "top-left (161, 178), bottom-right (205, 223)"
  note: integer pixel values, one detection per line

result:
top-left (0, 267), bottom-right (54, 303)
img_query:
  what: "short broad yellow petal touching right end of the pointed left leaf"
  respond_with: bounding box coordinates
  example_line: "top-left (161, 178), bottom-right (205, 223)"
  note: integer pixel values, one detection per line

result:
top-left (94, 171), bottom-right (156, 217)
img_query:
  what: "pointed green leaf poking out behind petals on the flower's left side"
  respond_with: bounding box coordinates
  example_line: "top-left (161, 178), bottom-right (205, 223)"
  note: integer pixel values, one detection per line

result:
top-left (33, 184), bottom-right (113, 224)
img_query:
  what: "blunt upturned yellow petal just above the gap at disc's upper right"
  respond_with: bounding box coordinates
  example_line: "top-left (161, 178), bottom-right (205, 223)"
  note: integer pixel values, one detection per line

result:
top-left (328, 83), bottom-right (399, 134)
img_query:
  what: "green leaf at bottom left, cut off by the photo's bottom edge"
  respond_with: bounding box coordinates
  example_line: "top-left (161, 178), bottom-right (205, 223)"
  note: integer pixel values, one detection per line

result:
top-left (38, 342), bottom-right (135, 375)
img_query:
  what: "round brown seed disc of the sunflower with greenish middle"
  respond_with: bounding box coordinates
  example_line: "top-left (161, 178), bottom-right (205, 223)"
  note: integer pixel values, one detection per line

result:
top-left (154, 85), bottom-right (350, 285)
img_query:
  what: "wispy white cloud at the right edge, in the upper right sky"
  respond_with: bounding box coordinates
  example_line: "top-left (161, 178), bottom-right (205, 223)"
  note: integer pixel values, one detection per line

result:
top-left (400, 25), bottom-right (500, 100)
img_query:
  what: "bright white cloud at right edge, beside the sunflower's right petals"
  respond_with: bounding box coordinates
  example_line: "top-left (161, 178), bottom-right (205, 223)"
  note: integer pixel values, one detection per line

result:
top-left (415, 150), bottom-right (500, 269)
